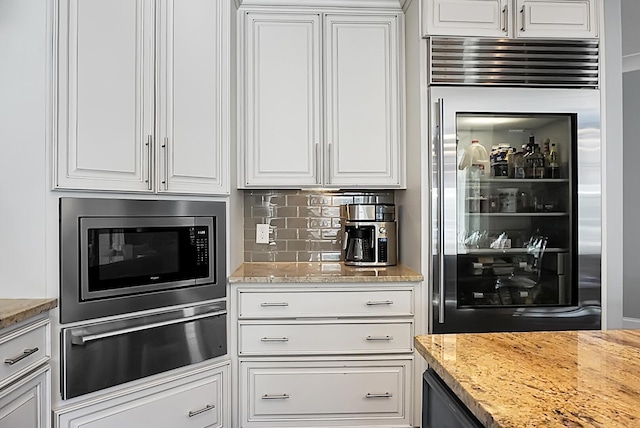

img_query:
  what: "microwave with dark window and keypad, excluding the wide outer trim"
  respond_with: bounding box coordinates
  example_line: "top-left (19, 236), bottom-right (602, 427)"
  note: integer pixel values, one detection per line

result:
top-left (80, 217), bottom-right (215, 301)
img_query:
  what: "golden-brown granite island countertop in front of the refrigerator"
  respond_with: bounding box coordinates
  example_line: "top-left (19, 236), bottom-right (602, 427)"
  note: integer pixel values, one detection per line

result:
top-left (415, 330), bottom-right (640, 428)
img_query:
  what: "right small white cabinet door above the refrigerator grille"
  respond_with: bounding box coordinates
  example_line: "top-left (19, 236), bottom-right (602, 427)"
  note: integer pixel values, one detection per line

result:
top-left (516, 0), bottom-right (598, 38)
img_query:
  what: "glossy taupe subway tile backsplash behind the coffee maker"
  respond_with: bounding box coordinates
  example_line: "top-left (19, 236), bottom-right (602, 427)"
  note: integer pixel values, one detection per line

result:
top-left (244, 190), bottom-right (394, 262)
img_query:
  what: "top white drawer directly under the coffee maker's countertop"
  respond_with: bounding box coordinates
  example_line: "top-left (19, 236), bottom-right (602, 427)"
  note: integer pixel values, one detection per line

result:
top-left (238, 289), bottom-right (413, 318)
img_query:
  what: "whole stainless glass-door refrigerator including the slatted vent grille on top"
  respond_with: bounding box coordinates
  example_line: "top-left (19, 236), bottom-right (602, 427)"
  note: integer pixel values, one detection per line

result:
top-left (428, 38), bottom-right (601, 333)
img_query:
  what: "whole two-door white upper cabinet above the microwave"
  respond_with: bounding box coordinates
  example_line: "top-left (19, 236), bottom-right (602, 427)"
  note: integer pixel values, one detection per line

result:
top-left (54, 0), bottom-right (230, 194)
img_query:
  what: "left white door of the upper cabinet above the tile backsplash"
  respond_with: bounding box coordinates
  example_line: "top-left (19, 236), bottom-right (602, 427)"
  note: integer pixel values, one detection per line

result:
top-left (239, 11), bottom-right (321, 188)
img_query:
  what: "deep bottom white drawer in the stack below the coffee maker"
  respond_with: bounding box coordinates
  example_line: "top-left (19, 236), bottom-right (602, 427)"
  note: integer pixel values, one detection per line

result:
top-left (241, 360), bottom-right (411, 427)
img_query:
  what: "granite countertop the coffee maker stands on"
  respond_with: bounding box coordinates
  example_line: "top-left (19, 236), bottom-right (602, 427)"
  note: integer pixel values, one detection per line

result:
top-left (229, 262), bottom-right (422, 283)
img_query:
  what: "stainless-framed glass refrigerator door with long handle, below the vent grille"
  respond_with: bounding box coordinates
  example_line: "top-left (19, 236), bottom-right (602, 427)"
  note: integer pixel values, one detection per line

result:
top-left (429, 87), bottom-right (601, 333)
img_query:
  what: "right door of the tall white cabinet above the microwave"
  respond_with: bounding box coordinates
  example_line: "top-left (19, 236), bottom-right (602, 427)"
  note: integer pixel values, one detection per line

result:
top-left (157, 0), bottom-right (230, 193)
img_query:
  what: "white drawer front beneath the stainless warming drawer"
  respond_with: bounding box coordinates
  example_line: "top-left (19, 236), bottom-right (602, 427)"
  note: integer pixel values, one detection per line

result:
top-left (59, 368), bottom-right (223, 428)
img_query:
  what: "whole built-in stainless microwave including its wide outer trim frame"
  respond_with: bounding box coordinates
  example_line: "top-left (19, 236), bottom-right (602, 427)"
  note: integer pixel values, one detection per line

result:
top-left (60, 198), bottom-right (226, 323)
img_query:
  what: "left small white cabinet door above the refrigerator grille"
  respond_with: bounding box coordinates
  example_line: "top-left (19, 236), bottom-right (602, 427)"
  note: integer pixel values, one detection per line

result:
top-left (422, 0), bottom-right (510, 37)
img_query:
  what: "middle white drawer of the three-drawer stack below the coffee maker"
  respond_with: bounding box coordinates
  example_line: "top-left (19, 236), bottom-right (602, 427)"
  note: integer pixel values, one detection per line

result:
top-left (238, 320), bottom-right (413, 355)
